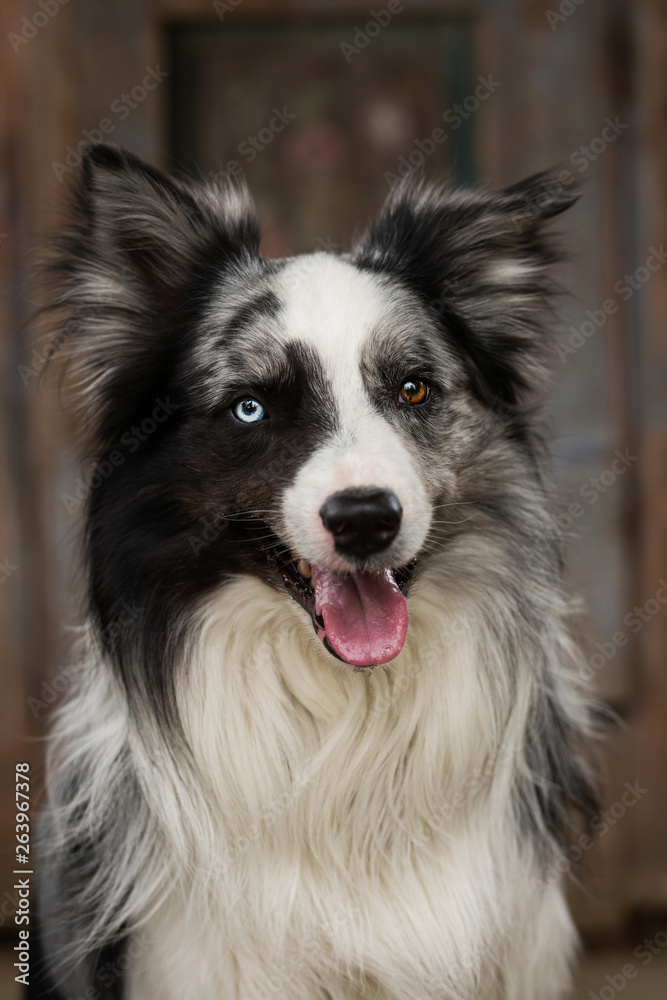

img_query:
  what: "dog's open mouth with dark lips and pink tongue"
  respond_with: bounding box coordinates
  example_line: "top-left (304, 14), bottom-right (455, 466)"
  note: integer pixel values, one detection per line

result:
top-left (267, 548), bottom-right (417, 669)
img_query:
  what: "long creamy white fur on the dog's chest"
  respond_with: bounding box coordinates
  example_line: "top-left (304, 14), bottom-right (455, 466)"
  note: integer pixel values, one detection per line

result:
top-left (125, 580), bottom-right (572, 1000)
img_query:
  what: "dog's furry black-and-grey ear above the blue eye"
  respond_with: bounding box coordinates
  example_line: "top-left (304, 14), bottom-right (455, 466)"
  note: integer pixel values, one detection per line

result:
top-left (39, 145), bottom-right (259, 451)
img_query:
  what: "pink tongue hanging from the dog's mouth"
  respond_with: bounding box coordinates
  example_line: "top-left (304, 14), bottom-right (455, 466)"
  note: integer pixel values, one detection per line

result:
top-left (313, 566), bottom-right (408, 667)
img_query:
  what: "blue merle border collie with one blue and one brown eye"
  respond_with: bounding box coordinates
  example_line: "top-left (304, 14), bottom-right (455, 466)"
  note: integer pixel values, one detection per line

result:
top-left (39, 146), bottom-right (596, 1000)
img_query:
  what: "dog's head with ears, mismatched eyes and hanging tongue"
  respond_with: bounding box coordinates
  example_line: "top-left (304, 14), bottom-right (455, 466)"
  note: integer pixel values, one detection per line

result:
top-left (50, 146), bottom-right (575, 700)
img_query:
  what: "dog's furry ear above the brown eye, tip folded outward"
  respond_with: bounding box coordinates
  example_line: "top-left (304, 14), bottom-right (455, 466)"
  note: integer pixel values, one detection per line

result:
top-left (354, 171), bottom-right (579, 411)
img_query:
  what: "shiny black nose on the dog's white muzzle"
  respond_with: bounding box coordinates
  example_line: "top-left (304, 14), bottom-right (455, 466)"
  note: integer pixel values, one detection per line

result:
top-left (320, 489), bottom-right (403, 559)
